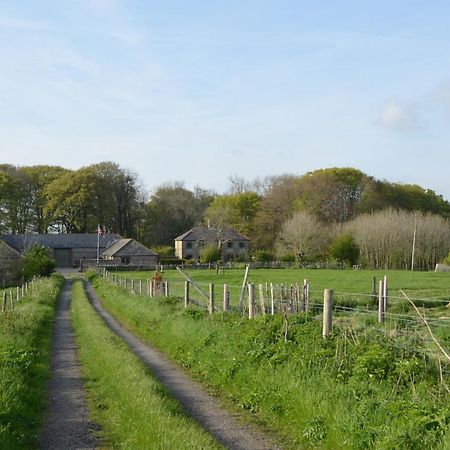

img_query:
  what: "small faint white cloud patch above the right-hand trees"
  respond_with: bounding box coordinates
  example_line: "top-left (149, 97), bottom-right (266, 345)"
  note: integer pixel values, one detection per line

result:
top-left (377, 99), bottom-right (424, 132)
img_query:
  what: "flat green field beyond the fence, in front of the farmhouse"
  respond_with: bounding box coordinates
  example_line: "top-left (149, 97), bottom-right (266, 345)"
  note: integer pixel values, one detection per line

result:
top-left (117, 269), bottom-right (450, 305)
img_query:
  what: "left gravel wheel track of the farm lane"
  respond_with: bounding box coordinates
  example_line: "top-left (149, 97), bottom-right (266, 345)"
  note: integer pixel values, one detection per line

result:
top-left (39, 279), bottom-right (98, 449)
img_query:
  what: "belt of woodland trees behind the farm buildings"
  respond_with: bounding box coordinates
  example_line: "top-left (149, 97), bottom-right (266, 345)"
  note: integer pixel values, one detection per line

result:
top-left (0, 162), bottom-right (450, 269)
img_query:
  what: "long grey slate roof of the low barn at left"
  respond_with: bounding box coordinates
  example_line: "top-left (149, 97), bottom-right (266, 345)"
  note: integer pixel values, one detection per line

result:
top-left (2, 233), bottom-right (122, 252)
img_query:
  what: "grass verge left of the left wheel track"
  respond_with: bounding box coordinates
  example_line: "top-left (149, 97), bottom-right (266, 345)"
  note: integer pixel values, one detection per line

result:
top-left (0, 276), bottom-right (64, 449)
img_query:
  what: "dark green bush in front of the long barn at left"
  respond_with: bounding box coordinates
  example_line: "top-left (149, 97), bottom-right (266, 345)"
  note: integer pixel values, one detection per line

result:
top-left (14, 245), bottom-right (55, 281)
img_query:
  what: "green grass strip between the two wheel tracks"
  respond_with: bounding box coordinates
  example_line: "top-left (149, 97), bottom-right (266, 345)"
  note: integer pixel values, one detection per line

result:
top-left (71, 280), bottom-right (221, 450)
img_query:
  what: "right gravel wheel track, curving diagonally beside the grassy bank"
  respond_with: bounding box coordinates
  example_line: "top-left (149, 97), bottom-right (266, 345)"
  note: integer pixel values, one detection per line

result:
top-left (84, 281), bottom-right (281, 450)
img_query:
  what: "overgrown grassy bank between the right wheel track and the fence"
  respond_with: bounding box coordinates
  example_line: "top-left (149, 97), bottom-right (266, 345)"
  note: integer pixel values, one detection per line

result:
top-left (88, 270), bottom-right (450, 450)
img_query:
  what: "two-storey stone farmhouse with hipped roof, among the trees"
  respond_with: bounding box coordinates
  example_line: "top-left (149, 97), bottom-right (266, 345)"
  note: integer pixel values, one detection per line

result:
top-left (175, 225), bottom-right (250, 261)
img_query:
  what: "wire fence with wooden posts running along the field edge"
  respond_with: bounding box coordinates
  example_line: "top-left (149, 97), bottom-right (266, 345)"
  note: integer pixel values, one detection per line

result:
top-left (102, 270), bottom-right (450, 376)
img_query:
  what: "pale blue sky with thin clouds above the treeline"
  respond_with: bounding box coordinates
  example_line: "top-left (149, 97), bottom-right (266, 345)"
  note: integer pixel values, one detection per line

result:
top-left (0, 0), bottom-right (450, 200)
